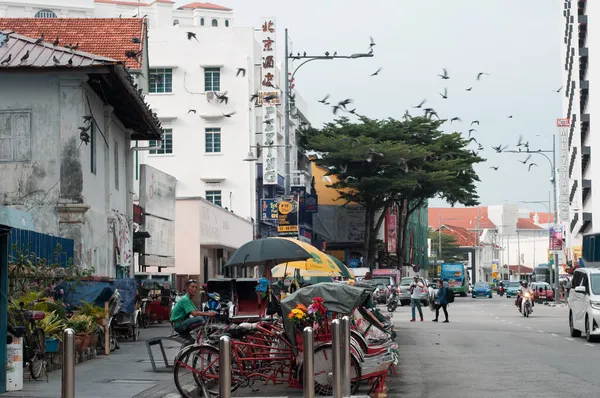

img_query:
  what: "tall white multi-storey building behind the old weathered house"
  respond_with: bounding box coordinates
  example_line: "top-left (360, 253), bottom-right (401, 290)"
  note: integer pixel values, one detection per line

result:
top-left (0, 0), bottom-right (311, 279)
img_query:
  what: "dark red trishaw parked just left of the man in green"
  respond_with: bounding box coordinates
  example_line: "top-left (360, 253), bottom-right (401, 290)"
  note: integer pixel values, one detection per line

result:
top-left (139, 279), bottom-right (173, 329)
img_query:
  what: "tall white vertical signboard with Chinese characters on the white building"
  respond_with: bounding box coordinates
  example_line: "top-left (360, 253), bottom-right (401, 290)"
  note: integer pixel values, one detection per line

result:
top-left (259, 18), bottom-right (280, 185)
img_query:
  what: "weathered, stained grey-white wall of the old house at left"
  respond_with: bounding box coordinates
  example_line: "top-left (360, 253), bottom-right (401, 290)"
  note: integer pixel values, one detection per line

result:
top-left (0, 74), bottom-right (132, 276)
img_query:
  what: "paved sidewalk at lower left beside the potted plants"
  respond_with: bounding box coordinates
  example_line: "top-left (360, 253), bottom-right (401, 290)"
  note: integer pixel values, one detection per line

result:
top-left (0, 323), bottom-right (179, 398)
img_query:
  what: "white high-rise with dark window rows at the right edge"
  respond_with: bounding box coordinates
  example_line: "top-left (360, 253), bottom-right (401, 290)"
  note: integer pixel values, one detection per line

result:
top-left (557, 0), bottom-right (600, 253)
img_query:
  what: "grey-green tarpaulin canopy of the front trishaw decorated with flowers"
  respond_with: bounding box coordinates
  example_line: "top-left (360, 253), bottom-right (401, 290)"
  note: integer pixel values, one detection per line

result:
top-left (281, 282), bottom-right (370, 345)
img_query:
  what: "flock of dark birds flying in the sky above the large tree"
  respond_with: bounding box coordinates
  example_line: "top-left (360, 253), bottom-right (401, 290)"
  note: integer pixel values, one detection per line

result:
top-left (310, 37), bottom-right (563, 175)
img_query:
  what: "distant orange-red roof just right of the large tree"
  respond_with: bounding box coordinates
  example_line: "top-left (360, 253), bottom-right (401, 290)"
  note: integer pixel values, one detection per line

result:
top-left (428, 207), bottom-right (496, 230)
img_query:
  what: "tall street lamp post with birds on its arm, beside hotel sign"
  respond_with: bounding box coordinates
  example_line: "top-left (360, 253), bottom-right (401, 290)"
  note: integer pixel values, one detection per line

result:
top-left (283, 29), bottom-right (373, 196)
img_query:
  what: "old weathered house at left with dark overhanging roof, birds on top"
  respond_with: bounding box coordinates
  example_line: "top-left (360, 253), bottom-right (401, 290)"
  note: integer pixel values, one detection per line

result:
top-left (0, 30), bottom-right (161, 277)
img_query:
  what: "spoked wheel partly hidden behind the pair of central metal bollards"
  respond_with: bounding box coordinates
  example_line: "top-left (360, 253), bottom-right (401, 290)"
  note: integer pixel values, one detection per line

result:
top-left (314, 343), bottom-right (361, 395)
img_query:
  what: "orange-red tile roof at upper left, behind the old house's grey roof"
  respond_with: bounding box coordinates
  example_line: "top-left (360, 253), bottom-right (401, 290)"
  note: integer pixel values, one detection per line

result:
top-left (0, 18), bottom-right (146, 69)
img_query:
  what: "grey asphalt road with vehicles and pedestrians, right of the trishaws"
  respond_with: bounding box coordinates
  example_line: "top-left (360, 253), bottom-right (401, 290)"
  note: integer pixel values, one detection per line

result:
top-left (388, 295), bottom-right (600, 398)
